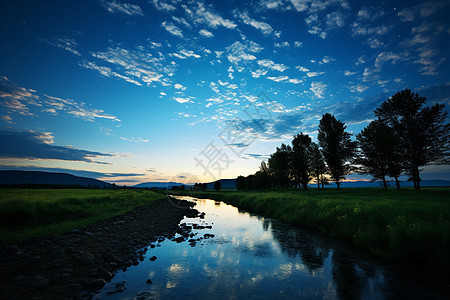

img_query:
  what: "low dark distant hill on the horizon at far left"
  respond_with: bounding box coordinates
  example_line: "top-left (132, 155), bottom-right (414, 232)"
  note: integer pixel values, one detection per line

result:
top-left (0, 171), bottom-right (111, 187)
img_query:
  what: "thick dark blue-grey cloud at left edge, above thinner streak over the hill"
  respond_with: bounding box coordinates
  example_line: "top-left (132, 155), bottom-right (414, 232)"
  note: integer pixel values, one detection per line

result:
top-left (0, 129), bottom-right (113, 164)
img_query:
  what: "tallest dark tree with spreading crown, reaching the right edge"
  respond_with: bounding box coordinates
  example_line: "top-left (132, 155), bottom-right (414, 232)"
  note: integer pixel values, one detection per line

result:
top-left (375, 89), bottom-right (450, 189)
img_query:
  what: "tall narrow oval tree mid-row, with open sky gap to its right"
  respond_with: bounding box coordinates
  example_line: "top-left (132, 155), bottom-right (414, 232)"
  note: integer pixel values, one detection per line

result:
top-left (318, 113), bottom-right (356, 190)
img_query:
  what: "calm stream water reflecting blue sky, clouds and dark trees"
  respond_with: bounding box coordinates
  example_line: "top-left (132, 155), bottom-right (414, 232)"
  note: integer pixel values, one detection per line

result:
top-left (96, 197), bottom-right (448, 300)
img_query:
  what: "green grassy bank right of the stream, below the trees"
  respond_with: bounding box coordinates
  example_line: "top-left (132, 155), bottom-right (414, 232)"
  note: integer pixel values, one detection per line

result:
top-left (171, 188), bottom-right (450, 272)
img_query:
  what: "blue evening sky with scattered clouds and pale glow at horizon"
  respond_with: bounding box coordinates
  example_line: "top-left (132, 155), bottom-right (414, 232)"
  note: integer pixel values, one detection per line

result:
top-left (0, 0), bottom-right (450, 186)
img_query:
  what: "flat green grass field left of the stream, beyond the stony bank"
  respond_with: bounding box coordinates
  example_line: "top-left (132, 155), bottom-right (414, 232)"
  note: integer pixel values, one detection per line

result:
top-left (0, 188), bottom-right (164, 245)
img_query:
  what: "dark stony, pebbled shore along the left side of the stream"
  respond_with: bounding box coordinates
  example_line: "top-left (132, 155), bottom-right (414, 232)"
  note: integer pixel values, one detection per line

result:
top-left (0, 197), bottom-right (198, 299)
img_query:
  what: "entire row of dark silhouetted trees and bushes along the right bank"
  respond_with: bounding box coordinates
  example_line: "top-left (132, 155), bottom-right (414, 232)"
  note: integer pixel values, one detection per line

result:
top-left (236, 89), bottom-right (450, 190)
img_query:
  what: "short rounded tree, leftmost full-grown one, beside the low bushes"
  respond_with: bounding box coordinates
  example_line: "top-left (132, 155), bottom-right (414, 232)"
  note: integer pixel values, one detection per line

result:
top-left (269, 144), bottom-right (292, 188)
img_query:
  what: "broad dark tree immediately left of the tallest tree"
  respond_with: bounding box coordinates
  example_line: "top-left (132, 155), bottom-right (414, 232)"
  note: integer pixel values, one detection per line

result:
top-left (356, 119), bottom-right (403, 189)
